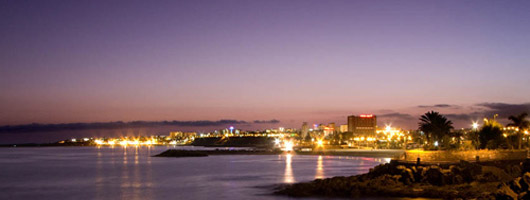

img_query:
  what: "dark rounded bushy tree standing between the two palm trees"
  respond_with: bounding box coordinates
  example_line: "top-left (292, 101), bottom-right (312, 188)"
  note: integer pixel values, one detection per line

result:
top-left (478, 119), bottom-right (506, 149)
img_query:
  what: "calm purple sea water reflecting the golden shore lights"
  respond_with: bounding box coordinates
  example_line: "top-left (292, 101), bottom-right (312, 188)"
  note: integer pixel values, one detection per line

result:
top-left (0, 147), bottom-right (390, 199)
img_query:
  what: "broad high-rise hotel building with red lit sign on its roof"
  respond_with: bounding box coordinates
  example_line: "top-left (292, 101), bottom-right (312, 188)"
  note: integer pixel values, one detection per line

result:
top-left (348, 115), bottom-right (377, 135)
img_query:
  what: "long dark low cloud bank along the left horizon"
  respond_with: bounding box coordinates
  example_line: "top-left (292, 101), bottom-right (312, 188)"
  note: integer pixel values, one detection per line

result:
top-left (0, 119), bottom-right (280, 133)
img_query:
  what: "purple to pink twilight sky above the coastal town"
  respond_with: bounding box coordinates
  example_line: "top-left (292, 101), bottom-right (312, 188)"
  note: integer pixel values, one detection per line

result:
top-left (0, 0), bottom-right (530, 128)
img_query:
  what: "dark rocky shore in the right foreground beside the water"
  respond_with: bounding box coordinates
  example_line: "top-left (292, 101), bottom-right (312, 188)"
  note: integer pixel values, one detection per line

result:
top-left (276, 161), bottom-right (530, 199)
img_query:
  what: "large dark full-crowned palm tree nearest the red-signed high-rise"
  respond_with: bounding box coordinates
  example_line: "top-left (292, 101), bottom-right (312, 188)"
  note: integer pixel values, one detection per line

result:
top-left (418, 111), bottom-right (453, 148)
